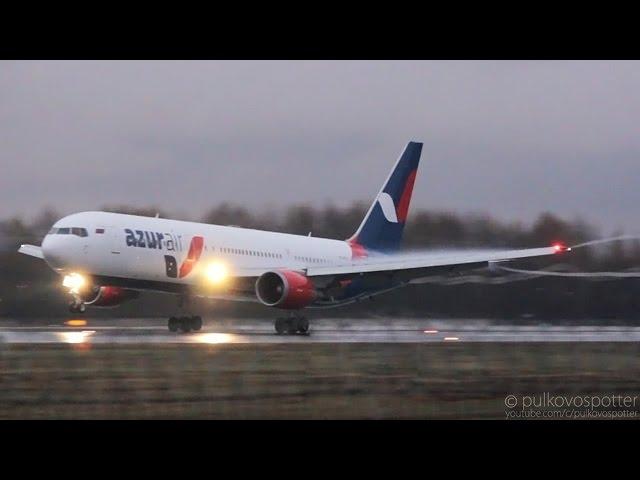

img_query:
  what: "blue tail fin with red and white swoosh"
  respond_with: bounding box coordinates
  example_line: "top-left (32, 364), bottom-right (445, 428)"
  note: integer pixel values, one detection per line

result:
top-left (348, 142), bottom-right (422, 252)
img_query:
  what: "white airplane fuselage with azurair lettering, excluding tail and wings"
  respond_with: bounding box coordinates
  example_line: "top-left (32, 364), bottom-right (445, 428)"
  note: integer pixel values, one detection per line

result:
top-left (42, 212), bottom-right (352, 285)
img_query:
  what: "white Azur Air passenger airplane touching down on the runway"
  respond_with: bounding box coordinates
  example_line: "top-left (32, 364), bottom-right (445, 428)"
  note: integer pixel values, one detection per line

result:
top-left (18, 141), bottom-right (570, 335)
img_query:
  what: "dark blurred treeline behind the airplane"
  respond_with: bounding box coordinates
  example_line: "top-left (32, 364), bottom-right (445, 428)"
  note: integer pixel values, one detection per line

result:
top-left (0, 203), bottom-right (640, 322)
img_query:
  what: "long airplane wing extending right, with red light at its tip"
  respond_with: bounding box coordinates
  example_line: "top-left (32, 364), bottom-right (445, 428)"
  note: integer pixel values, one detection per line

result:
top-left (306, 245), bottom-right (570, 282)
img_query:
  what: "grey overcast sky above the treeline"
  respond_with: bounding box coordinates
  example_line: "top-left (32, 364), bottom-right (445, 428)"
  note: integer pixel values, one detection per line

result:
top-left (0, 61), bottom-right (640, 233)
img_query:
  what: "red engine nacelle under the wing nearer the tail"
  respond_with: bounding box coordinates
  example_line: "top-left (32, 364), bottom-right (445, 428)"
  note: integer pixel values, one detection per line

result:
top-left (256, 270), bottom-right (318, 310)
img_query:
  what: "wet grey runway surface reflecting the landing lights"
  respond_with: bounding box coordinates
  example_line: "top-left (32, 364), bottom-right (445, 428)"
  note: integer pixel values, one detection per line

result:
top-left (0, 319), bottom-right (640, 344)
